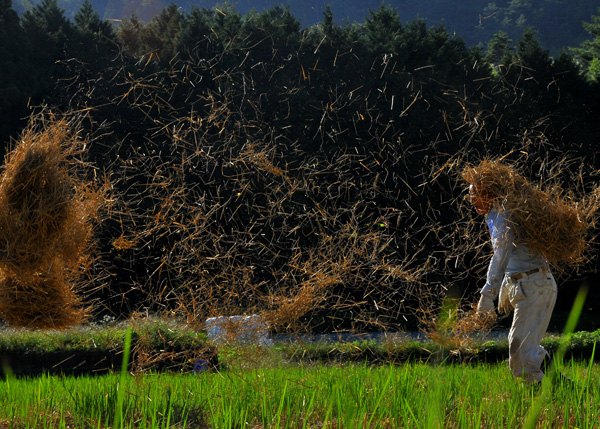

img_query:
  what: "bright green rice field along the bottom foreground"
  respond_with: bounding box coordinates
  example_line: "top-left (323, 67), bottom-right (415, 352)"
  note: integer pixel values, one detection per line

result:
top-left (0, 356), bottom-right (600, 428)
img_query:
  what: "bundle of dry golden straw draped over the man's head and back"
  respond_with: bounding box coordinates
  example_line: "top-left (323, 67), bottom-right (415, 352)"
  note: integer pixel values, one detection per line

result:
top-left (461, 160), bottom-right (598, 265)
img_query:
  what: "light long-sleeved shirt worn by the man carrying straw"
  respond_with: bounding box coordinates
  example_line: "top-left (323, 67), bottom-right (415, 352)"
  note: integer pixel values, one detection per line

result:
top-left (481, 207), bottom-right (548, 299)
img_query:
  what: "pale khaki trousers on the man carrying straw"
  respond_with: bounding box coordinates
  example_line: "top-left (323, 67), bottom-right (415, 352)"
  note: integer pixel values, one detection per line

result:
top-left (502, 270), bottom-right (557, 382)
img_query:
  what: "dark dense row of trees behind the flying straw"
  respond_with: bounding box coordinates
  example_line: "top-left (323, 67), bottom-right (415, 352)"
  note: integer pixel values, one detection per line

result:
top-left (0, 0), bottom-right (600, 330)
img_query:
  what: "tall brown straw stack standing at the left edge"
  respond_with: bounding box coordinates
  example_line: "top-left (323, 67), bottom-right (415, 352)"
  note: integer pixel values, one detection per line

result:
top-left (0, 119), bottom-right (103, 328)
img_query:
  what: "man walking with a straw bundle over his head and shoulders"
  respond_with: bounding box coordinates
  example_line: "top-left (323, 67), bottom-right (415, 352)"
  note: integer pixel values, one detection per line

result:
top-left (462, 160), bottom-right (588, 383)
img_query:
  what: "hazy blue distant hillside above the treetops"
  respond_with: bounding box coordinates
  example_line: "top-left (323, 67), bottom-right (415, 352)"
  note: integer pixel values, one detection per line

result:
top-left (13, 0), bottom-right (600, 54)
